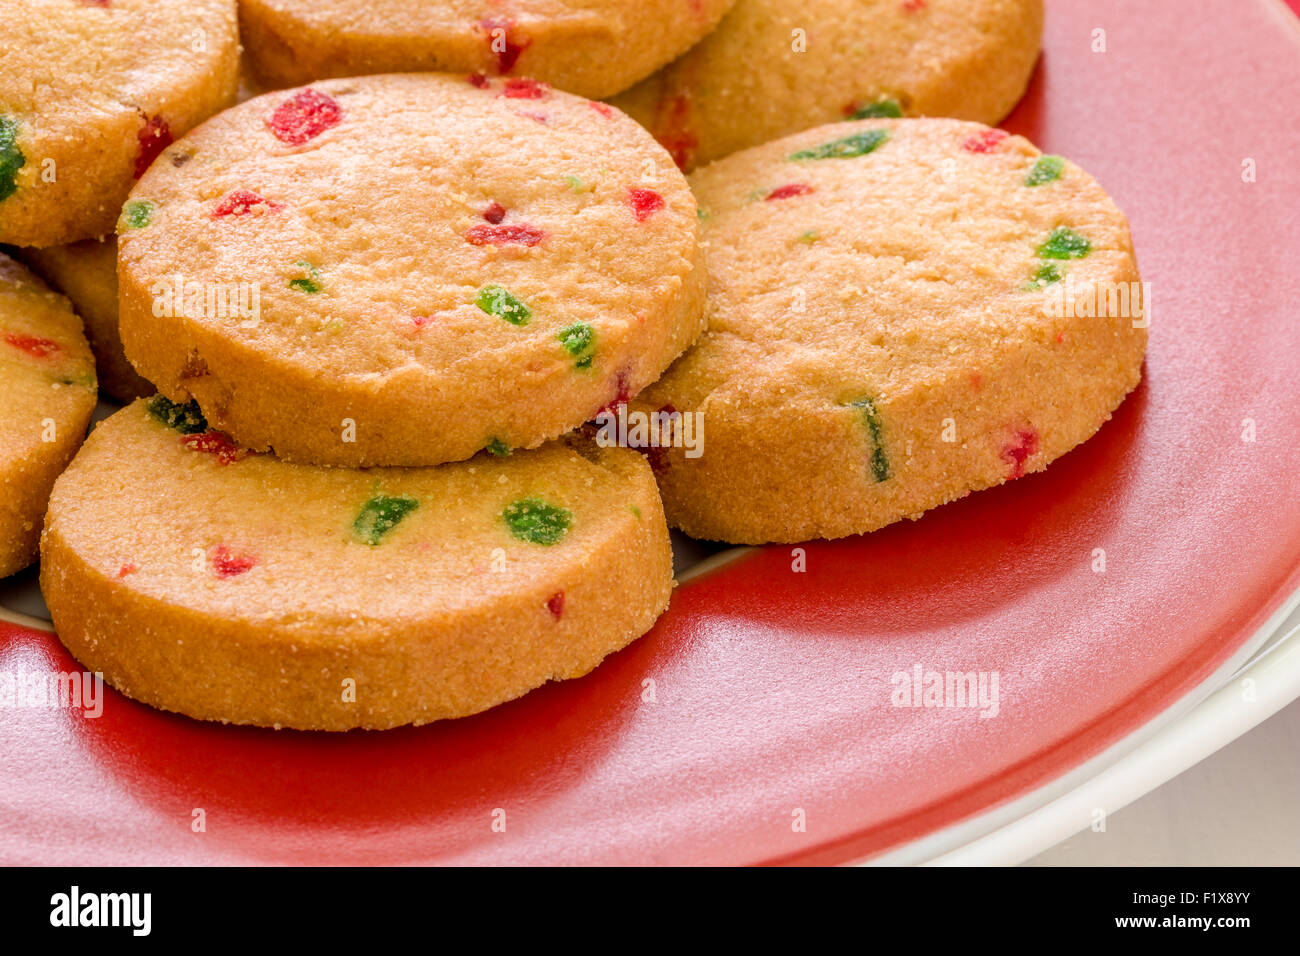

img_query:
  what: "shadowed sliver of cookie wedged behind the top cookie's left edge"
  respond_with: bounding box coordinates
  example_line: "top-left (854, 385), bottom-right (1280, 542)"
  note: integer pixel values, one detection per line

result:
top-left (23, 237), bottom-right (153, 402)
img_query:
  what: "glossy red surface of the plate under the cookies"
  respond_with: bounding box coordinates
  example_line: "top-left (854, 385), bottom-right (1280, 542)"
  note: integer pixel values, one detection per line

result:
top-left (0, 0), bottom-right (1300, 864)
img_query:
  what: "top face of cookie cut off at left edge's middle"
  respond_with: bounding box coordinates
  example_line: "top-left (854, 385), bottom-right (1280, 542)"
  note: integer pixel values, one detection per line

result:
top-left (0, 255), bottom-right (95, 463)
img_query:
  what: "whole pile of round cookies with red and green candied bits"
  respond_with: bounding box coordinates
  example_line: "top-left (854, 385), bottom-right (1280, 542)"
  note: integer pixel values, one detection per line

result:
top-left (0, 0), bottom-right (1145, 730)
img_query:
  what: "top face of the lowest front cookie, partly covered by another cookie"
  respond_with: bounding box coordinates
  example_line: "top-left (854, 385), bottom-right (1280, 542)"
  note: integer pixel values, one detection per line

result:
top-left (51, 397), bottom-right (662, 637)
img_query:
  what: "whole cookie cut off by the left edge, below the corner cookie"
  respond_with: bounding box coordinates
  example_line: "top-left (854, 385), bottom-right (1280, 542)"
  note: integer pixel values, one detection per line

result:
top-left (0, 255), bottom-right (95, 578)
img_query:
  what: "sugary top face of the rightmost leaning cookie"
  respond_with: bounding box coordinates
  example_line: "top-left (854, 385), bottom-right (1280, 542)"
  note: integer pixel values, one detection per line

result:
top-left (653, 120), bottom-right (1132, 408)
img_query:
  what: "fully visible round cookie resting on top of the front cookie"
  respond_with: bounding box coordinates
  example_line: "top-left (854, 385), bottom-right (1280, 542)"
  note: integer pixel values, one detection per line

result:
top-left (118, 74), bottom-right (705, 466)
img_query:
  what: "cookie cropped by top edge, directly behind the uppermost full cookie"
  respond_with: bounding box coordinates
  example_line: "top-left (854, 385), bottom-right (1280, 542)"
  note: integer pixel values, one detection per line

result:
top-left (239, 0), bottom-right (736, 98)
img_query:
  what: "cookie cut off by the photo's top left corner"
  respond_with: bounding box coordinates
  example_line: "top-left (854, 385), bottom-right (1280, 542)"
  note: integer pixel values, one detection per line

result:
top-left (0, 0), bottom-right (239, 246)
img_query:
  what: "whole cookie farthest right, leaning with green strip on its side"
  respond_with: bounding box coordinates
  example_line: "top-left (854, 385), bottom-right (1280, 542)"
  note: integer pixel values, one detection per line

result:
top-left (632, 120), bottom-right (1147, 544)
